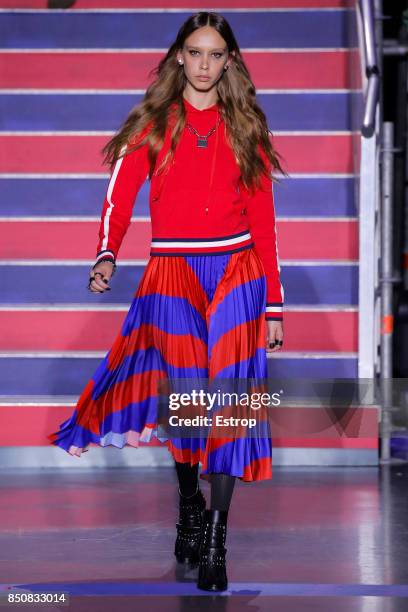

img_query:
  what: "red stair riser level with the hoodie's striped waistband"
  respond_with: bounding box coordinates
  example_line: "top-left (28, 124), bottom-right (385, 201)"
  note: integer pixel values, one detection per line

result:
top-left (0, 219), bottom-right (358, 260)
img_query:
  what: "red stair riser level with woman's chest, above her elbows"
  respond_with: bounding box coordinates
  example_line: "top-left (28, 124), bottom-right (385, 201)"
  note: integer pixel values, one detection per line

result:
top-left (0, 133), bottom-right (353, 174)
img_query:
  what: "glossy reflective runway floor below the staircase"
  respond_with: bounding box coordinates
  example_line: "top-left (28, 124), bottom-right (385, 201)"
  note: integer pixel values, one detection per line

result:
top-left (0, 463), bottom-right (408, 612)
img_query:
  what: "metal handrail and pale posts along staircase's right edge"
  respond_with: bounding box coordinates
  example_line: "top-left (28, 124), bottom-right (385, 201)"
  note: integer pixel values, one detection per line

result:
top-left (358, 0), bottom-right (407, 464)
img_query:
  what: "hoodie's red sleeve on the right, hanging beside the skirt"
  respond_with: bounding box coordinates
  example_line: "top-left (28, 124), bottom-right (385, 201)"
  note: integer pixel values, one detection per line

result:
top-left (239, 147), bottom-right (284, 321)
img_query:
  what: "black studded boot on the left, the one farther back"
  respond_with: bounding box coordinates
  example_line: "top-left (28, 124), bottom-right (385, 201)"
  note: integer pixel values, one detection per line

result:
top-left (174, 487), bottom-right (206, 563)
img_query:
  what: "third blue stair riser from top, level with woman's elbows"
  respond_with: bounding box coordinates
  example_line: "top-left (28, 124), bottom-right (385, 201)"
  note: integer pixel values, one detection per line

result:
top-left (0, 177), bottom-right (356, 218)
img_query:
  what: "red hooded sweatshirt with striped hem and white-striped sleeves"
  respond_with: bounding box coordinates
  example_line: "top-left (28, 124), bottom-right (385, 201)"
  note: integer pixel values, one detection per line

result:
top-left (96, 98), bottom-right (284, 320)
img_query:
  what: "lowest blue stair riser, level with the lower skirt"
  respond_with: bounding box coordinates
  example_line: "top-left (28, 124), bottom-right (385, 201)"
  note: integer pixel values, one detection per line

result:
top-left (0, 356), bottom-right (357, 395)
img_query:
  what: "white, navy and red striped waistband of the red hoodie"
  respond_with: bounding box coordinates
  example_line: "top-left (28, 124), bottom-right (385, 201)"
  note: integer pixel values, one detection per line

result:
top-left (150, 231), bottom-right (254, 256)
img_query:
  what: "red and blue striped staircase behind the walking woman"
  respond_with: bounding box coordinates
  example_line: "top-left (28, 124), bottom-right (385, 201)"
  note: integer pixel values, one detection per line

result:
top-left (0, 0), bottom-right (378, 467)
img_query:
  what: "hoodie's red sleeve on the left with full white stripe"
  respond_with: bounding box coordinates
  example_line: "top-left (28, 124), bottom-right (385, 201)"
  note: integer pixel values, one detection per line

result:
top-left (96, 125), bottom-right (149, 262)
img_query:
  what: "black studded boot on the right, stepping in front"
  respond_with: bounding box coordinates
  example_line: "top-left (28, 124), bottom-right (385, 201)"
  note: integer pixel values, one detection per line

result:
top-left (197, 510), bottom-right (228, 591)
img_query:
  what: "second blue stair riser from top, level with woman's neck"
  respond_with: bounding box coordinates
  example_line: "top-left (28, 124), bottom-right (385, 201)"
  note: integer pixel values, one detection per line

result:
top-left (0, 92), bottom-right (363, 132)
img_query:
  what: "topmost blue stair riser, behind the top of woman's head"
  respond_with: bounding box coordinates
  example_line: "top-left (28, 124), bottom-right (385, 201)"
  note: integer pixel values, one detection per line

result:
top-left (0, 10), bottom-right (356, 49)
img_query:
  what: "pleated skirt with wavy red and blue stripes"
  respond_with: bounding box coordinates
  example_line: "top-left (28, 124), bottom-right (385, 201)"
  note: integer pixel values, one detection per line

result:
top-left (48, 247), bottom-right (272, 482)
